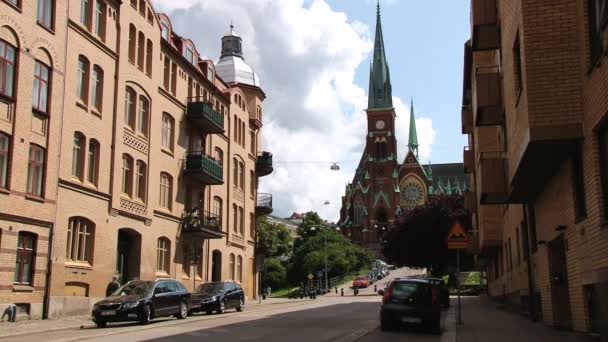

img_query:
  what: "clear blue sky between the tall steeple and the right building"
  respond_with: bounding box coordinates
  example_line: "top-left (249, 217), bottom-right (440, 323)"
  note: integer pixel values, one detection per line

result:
top-left (327, 0), bottom-right (470, 163)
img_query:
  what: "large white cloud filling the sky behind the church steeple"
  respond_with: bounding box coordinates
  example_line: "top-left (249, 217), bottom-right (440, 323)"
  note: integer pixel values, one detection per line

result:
top-left (154, 0), bottom-right (435, 220)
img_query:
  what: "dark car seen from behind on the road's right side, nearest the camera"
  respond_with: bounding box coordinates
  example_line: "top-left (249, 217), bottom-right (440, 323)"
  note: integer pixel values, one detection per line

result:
top-left (378, 278), bottom-right (441, 334)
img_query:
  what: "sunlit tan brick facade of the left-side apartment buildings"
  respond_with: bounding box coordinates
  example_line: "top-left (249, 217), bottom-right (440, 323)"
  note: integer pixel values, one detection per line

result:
top-left (0, 0), bottom-right (265, 318)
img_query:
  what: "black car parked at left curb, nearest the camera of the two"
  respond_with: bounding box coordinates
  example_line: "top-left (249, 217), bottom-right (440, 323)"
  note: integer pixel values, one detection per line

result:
top-left (92, 279), bottom-right (190, 328)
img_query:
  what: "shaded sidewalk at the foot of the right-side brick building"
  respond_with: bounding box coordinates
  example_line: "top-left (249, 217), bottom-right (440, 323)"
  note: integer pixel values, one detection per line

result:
top-left (450, 296), bottom-right (595, 342)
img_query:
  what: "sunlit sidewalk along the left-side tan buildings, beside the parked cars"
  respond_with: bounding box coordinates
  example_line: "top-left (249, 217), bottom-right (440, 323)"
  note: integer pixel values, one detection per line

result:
top-left (0, 298), bottom-right (301, 339)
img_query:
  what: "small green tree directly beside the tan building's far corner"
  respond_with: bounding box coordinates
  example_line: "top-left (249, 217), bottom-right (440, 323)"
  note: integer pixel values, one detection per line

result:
top-left (258, 217), bottom-right (292, 258)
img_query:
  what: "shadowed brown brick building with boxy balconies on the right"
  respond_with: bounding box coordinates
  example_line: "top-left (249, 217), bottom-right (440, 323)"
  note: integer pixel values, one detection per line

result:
top-left (462, 0), bottom-right (608, 337)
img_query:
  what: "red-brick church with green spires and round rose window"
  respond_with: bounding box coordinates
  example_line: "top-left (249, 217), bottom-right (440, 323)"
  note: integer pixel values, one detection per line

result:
top-left (339, 5), bottom-right (470, 256)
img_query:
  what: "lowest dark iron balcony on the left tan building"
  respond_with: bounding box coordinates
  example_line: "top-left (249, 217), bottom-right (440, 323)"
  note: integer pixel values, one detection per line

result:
top-left (182, 208), bottom-right (223, 239)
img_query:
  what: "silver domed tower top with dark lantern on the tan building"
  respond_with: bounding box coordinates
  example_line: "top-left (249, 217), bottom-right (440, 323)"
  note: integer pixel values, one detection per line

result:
top-left (215, 25), bottom-right (261, 88)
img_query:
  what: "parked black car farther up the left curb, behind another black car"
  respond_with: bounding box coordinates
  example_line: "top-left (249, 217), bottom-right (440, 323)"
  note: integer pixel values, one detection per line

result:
top-left (190, 281), bottom-right (245, 314)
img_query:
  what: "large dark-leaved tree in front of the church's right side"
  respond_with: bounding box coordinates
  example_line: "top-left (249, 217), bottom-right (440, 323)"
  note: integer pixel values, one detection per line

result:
top-left (383, 195), bottom-right (471, 275)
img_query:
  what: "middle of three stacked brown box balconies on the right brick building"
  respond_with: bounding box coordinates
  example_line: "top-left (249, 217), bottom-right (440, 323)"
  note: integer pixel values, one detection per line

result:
top-left (473, 65), bottom-right (505, 126)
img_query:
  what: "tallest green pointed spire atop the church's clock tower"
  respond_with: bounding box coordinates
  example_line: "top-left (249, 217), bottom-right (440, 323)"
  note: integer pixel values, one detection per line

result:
top-left (367, 0), bottom-right (393, 109)
